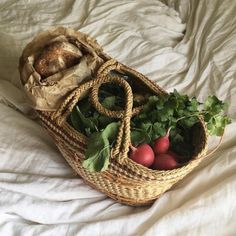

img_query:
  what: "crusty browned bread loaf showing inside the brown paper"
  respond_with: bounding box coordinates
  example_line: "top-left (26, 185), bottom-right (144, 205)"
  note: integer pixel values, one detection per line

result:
top-left (34, 42), bottom-right (82, 79)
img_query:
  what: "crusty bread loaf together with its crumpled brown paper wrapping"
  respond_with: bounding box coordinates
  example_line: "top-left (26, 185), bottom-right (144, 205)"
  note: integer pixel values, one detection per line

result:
top-left (19, 27), bottom-right (105, 111)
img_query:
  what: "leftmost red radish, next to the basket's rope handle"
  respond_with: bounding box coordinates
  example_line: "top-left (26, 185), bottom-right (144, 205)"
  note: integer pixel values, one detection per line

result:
top-left (129, 144), bottom-right (155, 167)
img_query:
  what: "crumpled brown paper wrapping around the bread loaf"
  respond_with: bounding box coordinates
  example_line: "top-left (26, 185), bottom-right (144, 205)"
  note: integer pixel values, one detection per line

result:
top-left (19, 27), bottom-right (104, 111)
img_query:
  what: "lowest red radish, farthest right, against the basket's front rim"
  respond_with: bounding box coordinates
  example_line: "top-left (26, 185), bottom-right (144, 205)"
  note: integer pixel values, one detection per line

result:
top-left (153, 153), bottom-right (179, 170)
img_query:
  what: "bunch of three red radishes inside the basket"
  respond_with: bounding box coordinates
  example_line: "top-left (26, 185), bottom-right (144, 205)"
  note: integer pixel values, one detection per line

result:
top-left (130, 129), bottom-right (179, 170)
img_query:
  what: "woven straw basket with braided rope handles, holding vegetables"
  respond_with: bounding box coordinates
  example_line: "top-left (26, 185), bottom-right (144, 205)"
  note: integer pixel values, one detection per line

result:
top-left (20, 27), bottom-right (207, 206)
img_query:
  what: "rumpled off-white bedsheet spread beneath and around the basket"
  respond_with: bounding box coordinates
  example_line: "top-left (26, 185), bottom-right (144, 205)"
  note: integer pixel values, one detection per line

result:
top-left (0, 0), bottom-right (236, 236)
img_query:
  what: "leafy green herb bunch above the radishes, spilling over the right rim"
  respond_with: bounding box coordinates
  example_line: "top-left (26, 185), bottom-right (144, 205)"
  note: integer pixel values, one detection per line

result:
top-left (131, 90), bottom-right (231, 156)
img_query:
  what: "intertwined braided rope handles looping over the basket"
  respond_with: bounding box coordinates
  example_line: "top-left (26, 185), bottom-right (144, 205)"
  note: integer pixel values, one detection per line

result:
top-left (52, 59), bottom-right (147, 163)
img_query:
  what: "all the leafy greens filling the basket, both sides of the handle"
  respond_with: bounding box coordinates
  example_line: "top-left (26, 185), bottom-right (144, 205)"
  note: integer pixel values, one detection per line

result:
top-left (69, 81), bottom-right (231, 171)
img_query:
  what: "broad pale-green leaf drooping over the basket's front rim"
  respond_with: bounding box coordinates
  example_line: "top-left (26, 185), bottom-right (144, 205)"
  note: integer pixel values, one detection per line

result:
top-left (82, 132), bottom-right (110, 172)
